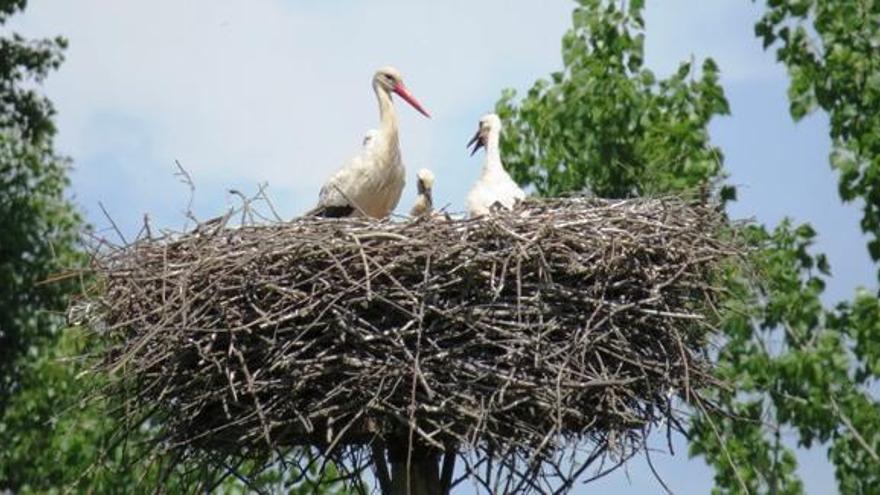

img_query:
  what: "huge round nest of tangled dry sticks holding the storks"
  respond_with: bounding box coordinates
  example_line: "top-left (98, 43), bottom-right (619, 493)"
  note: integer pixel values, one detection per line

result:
top-left (89, 198), bottom-right (736, 491)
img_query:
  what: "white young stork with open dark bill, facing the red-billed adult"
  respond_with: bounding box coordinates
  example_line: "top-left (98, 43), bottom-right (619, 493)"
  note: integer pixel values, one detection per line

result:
top-left (467, 113), bottom-right (526, 217)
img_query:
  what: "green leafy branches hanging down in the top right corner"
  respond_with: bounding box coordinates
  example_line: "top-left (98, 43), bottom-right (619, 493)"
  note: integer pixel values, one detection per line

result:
top-left (755, 0), bottom-right (880, 275)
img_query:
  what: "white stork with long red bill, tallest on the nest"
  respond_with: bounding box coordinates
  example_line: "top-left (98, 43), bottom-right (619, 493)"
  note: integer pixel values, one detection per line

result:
top-left (307, 67), bottom-right (430, 218)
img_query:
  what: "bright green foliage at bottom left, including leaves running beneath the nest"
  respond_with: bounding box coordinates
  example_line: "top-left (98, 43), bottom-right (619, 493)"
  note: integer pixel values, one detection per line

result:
top-left (0, 329), bottom-right (347, 495)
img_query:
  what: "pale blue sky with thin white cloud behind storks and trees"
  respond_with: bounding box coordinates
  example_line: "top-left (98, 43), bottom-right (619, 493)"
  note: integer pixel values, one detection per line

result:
top-left (4, 0), bottom-right (877, 494)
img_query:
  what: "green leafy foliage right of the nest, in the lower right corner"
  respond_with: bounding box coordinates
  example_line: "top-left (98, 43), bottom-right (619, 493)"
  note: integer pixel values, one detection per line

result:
top-left (691, 221), bottom-right (880, 493)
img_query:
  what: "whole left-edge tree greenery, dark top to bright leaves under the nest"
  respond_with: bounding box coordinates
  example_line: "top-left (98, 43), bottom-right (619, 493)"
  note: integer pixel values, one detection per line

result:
top-left (0, 0), bottom-right (356, 494)
